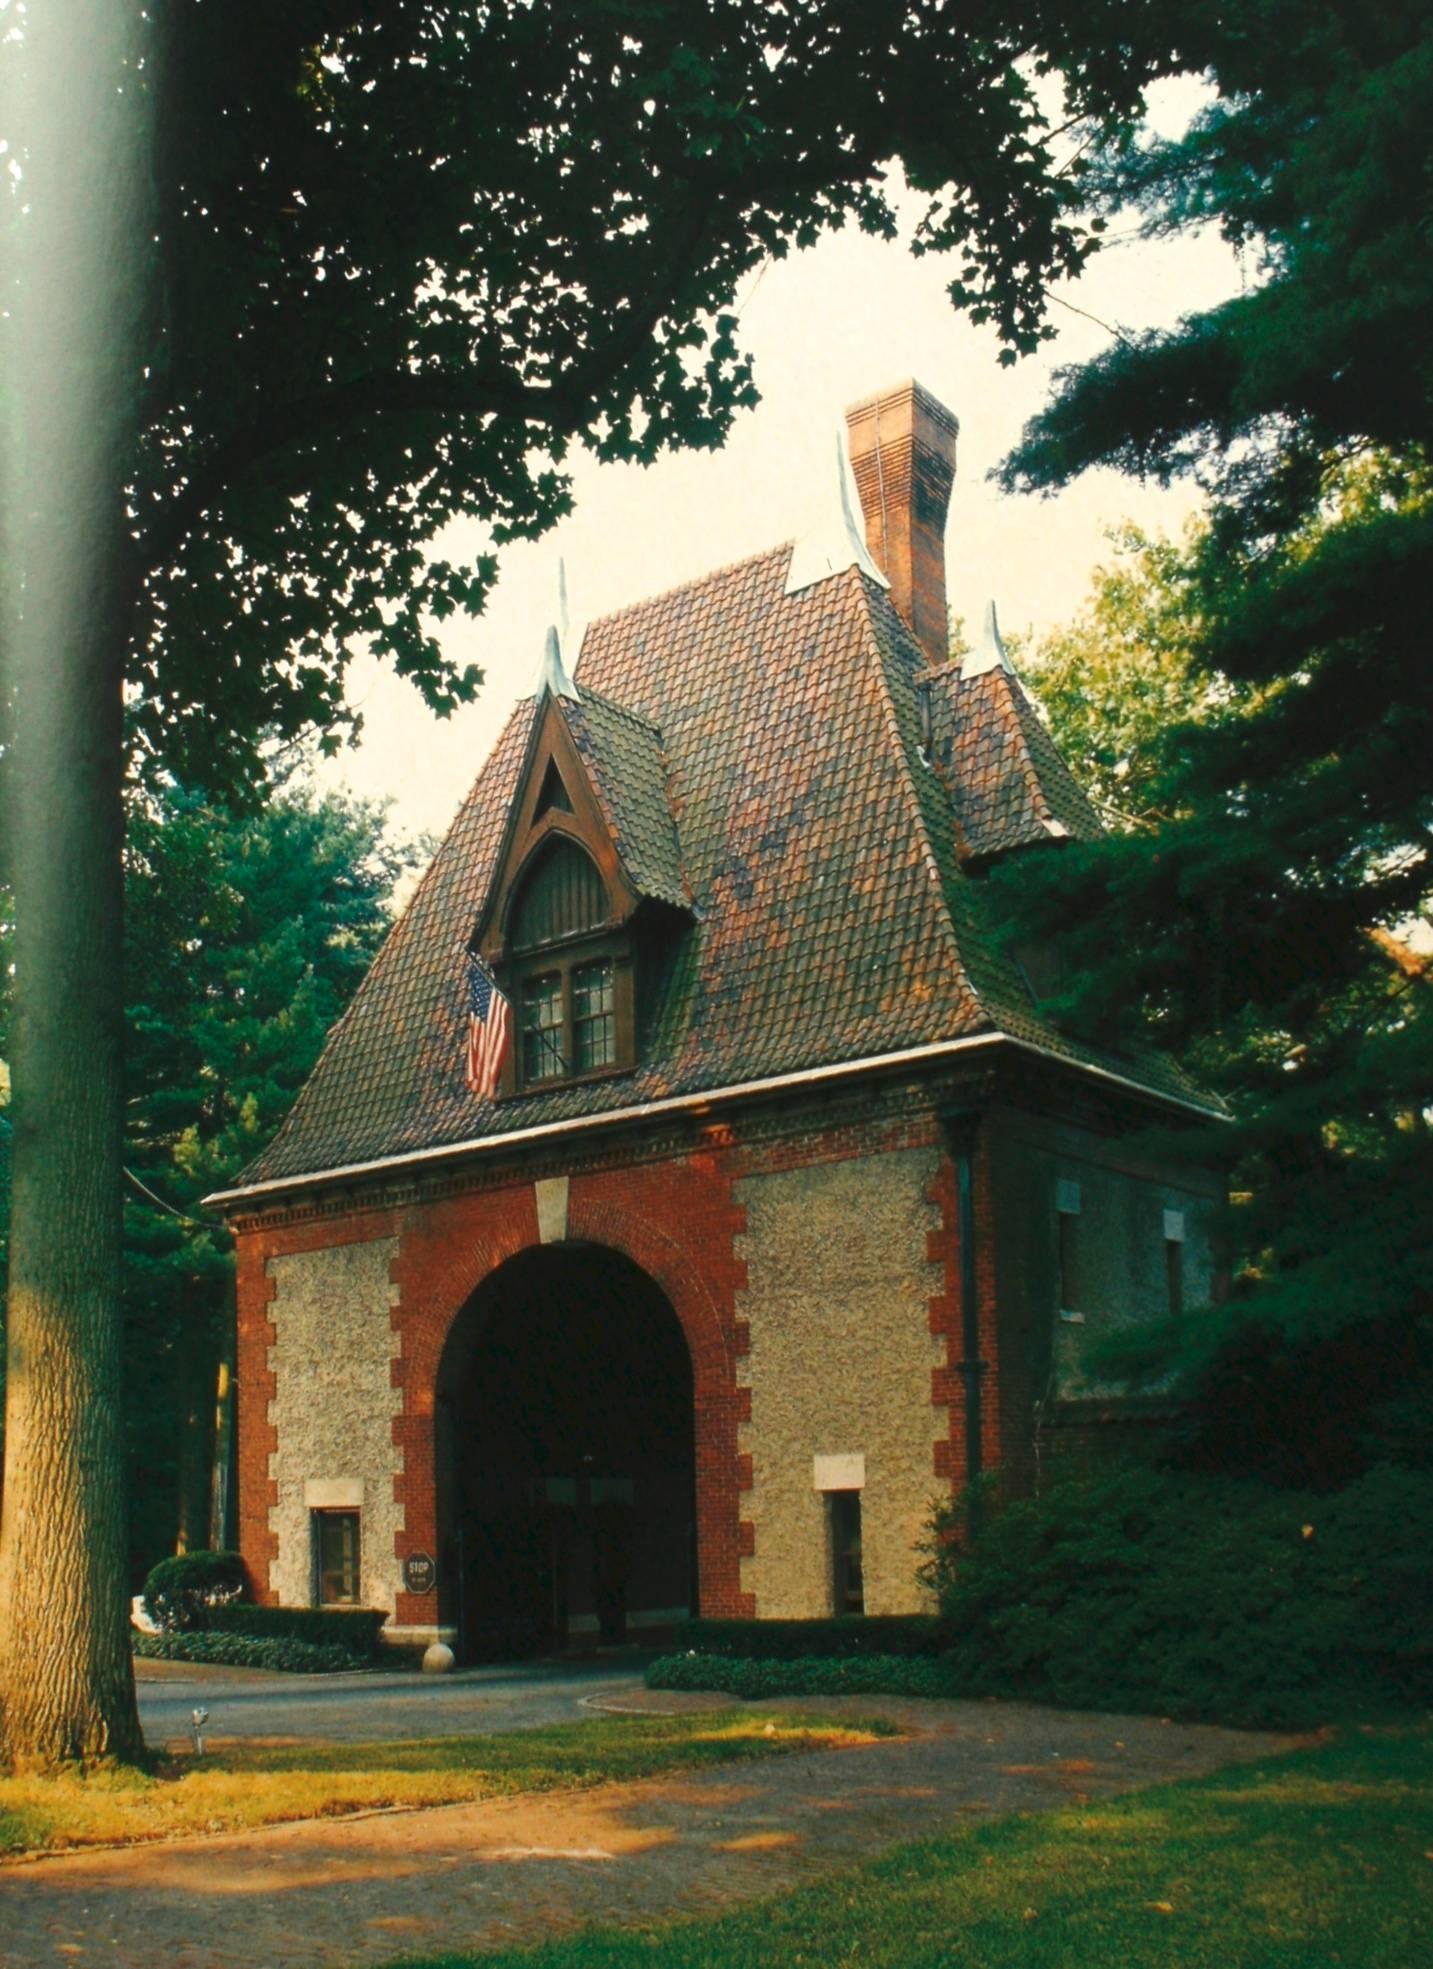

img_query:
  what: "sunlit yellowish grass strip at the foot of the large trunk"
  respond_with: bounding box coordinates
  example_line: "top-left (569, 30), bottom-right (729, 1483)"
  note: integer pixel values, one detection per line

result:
top-left (0, 1711), bottom-right (892, 1857)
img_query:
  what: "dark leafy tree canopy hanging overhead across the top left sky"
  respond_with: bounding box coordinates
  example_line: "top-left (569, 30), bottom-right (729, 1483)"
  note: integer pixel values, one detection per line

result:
top-left (114, 0), bottom-right (1212, 786)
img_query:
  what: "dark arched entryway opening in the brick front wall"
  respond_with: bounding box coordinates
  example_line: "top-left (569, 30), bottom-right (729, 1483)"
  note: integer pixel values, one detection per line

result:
top-left (435, 1242), bottom-right (697, 1660)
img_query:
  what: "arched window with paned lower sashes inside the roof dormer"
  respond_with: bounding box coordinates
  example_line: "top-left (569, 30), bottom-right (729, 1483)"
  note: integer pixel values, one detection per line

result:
top-left (506, 835), bottom-right (632, 1091)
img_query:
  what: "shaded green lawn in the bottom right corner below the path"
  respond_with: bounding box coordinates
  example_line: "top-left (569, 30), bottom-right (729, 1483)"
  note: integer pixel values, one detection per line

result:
top-left (389, 1729), bottom-right (1433, 1969)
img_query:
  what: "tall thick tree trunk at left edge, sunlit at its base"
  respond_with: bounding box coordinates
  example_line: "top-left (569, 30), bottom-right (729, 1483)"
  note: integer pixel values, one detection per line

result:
top-left (0, 0), bottom-right (146, 1766)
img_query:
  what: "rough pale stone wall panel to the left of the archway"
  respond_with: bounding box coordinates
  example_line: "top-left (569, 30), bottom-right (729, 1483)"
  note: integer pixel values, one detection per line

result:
top-left (268, 1239), bottom-right (404, 1609)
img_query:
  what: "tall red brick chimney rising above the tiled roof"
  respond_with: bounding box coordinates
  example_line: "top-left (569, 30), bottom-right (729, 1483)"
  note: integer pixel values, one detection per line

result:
top-left (846, 382), bottom-right (961, 664)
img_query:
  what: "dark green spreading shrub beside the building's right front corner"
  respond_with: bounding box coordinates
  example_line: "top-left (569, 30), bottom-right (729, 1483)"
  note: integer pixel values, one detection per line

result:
top-left (931, 1465), bottom-right (1433, 1727)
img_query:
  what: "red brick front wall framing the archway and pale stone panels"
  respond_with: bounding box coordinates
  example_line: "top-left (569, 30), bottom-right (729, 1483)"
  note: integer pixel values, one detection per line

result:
top-left (238, 1112), bottom-right (1006, 1626)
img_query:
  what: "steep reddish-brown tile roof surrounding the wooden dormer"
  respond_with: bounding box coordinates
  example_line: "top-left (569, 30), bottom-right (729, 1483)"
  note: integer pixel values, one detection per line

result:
top-left (229, 543), bottom-right (1193, 1187)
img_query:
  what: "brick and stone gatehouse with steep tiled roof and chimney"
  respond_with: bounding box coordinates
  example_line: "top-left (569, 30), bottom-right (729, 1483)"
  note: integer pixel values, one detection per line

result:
top-left (213, 384), bottom-right (1222, 1658)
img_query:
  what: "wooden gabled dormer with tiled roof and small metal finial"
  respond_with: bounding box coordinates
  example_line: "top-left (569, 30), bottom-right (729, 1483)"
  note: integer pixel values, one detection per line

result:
top-left (474, 679), bottom-right (687, 1095)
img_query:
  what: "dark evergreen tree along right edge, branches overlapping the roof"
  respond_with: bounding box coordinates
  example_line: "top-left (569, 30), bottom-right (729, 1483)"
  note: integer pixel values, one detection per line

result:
top-left (992, 0), bottom-right (1433, 1453)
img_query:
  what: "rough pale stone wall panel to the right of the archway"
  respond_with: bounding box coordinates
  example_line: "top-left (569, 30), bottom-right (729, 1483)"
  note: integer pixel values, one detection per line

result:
top-left (736, 1146), bottom-right (947, 1619)
